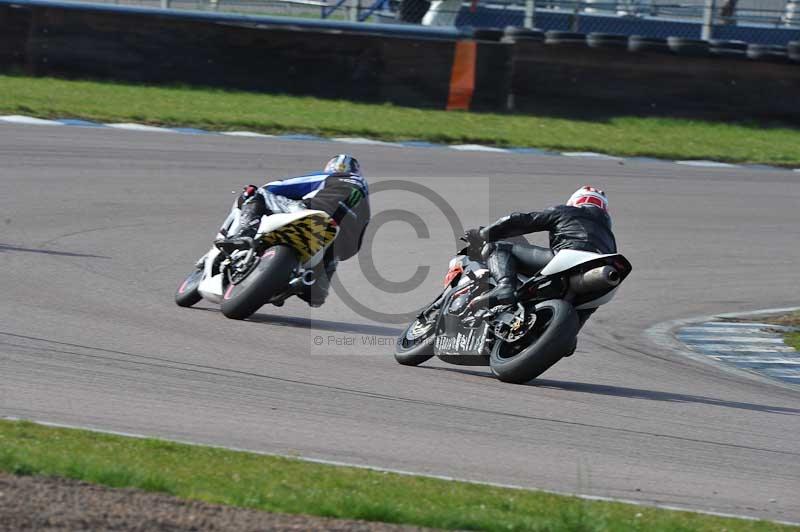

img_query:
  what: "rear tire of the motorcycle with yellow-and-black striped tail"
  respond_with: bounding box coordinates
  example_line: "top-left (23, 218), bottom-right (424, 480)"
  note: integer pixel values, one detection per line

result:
top-left (221, 246), bottom-right (298, 320)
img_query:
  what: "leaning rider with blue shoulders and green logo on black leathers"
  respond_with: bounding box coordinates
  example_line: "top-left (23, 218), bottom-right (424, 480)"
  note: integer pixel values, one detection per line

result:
top-left (219, 154), bottom-right (370, 307)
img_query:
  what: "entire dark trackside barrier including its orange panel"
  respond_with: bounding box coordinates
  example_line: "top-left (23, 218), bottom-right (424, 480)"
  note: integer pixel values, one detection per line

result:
top-left (0, 0), bottom-right (800, 123)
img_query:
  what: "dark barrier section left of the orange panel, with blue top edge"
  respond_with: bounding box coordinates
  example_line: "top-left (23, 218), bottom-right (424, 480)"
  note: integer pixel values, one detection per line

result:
top-left (0, 1), bottom-right (482, 108)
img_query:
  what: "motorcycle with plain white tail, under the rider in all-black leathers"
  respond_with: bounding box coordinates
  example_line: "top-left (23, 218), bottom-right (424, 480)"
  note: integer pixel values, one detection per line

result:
top-left (395, 240), bottom-right (631, 383)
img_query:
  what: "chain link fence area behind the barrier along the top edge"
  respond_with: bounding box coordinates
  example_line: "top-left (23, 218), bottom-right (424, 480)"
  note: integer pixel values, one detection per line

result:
top-left (61, 0), bottom-right (800, 40)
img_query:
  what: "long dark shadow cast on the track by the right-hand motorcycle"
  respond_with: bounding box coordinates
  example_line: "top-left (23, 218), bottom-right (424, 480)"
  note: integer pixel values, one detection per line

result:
top-left (421, 366), bottom-right (800, 416)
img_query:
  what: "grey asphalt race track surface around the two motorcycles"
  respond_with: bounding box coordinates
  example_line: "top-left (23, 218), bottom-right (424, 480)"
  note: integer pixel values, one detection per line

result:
top-left (0, 125), bottom-right (800, 522)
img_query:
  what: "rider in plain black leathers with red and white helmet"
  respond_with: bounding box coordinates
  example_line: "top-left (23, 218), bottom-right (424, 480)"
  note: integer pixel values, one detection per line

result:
top-left (466, 186), bottom-right (617, 327)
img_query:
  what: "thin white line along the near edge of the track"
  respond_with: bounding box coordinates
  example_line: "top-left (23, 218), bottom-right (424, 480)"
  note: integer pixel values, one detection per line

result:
top-left (0, 416), bottom-right (800, 526)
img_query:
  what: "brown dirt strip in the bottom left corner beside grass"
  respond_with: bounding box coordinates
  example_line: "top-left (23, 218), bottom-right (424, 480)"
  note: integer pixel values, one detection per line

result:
top-left (0, 472), bottom-right (438, 532)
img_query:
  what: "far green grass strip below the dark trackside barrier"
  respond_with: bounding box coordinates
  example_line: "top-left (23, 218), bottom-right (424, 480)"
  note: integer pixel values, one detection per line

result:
top-left (0, 76), bottom-right (800, 166)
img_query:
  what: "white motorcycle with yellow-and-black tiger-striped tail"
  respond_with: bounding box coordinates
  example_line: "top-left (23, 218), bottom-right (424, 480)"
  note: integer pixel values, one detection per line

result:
top-left (175, 206), bottom-right (339, 320)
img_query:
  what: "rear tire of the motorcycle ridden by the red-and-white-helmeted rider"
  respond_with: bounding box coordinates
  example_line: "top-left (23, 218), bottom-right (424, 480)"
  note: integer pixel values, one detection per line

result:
top-left (489, 299), bottom-right (579, 384)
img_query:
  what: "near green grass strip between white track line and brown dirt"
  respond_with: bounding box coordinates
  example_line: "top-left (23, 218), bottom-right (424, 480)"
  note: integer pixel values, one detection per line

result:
top-left (0, 421), bottom-right (800, 532)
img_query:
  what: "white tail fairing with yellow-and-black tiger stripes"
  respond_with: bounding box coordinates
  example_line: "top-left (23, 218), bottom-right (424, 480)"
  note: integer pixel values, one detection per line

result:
top-left (256, 209), bottom-right (339, 264)
